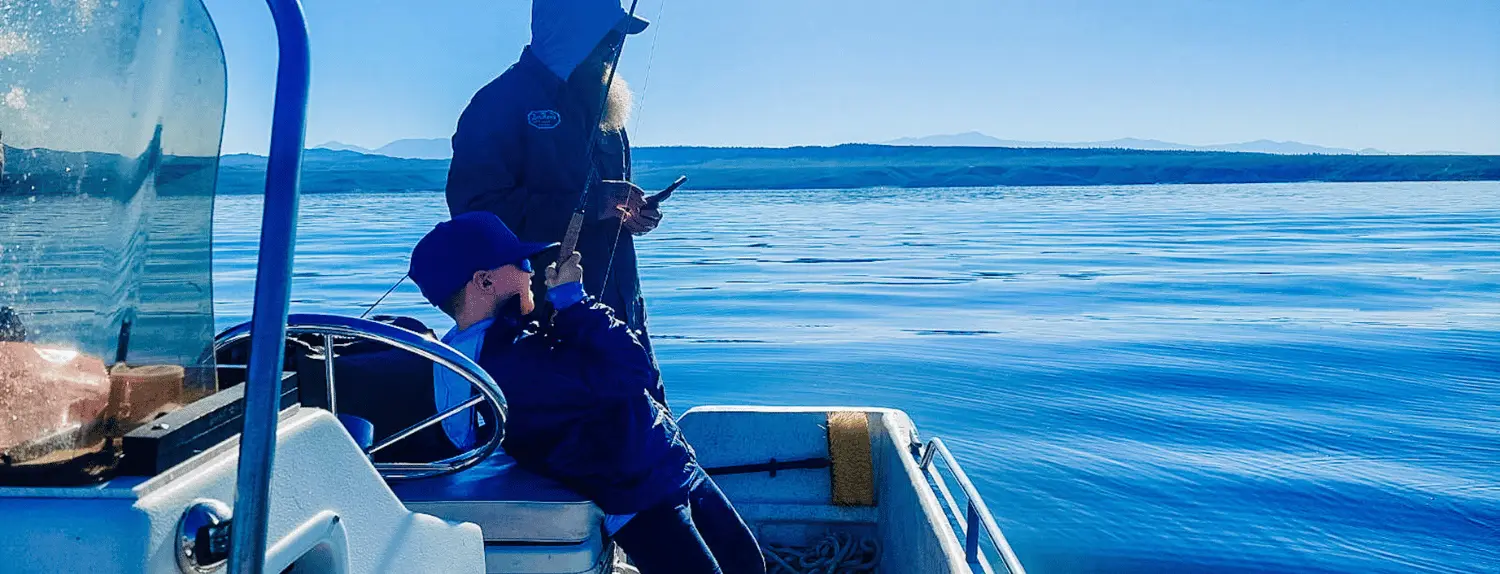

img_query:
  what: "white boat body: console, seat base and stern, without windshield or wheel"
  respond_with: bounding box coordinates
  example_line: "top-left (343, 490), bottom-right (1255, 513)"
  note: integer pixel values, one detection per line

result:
top-left (0, 406), bottom-right (1008, 574)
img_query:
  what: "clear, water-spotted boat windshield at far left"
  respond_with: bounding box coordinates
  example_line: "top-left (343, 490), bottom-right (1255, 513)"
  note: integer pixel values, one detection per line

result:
top-left (0, 0), bottom-right (225, 486)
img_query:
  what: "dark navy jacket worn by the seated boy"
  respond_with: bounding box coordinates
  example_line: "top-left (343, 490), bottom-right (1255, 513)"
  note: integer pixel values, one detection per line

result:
top-left (479, 298), bottom-right (704, 514)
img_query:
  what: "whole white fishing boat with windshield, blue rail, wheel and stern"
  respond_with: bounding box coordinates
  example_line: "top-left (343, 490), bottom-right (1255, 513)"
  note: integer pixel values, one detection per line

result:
top-left (0, 0), bottom-right (1023, 574)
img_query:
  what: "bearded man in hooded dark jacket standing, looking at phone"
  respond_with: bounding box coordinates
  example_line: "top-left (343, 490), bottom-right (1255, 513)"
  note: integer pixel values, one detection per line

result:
top-left (447, 0), bottom-right (663, 373)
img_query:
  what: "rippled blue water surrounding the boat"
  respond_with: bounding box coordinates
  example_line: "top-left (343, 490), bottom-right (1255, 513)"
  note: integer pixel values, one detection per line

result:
top-left (215, 183), bottom-right (1500, 573)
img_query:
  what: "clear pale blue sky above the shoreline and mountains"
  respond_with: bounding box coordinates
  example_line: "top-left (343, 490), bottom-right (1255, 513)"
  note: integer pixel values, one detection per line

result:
top-left (207, 0), bottom-right (1500, 153)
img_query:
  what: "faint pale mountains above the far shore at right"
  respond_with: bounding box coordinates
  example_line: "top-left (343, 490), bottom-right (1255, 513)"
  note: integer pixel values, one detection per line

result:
top-left (885, 132), bottom-right (1434, 156)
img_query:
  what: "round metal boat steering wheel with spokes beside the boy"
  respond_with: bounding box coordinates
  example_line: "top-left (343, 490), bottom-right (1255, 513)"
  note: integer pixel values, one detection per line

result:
top-left (213, 313), bottom-right (509, 480)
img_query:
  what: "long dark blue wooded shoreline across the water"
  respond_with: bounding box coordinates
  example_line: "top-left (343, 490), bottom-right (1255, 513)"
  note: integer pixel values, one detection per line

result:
top-left (196, 144), bottom-right (1500, 193)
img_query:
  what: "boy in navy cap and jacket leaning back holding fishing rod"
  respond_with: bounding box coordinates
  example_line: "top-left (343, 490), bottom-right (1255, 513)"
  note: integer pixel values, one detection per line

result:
top-left (411, 211), bottom-right (765, 574)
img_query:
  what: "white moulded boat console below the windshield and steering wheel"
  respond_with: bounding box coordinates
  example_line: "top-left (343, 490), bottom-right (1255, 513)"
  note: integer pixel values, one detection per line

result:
top-left (0, 409), bottom-right (485, 574)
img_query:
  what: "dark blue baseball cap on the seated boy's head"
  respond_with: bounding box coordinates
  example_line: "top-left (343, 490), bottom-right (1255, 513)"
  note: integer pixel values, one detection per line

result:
top-left (410, 211), bottom-right (558, 306)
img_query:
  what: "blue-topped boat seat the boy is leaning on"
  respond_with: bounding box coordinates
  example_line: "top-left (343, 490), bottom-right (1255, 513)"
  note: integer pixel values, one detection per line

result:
top-left (392, 454), bottom-right (605, 544)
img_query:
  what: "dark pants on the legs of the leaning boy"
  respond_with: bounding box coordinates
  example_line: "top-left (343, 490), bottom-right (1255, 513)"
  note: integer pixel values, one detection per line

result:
top-left (615, 478), bottom-right (765, 574)
